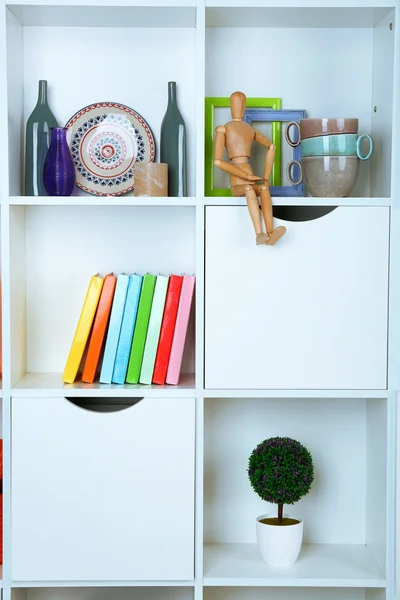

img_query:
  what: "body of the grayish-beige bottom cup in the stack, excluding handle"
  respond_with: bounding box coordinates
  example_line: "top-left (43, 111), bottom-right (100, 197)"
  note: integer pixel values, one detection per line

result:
top-left (302, 156), bottom-right (360, 198)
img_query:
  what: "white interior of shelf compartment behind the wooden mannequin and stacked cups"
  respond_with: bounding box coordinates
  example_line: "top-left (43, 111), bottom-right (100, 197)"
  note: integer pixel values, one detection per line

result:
top-left (205, 7), bottom-right (395, 198)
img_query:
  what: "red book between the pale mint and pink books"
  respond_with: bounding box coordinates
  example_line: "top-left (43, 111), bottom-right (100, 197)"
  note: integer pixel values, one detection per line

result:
top-left (153, 275), bottom-right (183, 385)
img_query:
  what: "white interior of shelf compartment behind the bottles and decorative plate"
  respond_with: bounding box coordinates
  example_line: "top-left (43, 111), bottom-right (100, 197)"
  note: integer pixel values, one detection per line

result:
top-left (7, 8), bottom-right (197, 196)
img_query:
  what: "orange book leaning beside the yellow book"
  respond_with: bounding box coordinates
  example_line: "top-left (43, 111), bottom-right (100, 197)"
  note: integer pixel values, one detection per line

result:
top-left (82, 273), bottom-right (117, 383)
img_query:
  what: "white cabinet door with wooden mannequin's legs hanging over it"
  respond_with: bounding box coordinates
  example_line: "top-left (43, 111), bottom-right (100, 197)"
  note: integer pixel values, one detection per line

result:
top-left (205, 206), bottom-right (389, 389)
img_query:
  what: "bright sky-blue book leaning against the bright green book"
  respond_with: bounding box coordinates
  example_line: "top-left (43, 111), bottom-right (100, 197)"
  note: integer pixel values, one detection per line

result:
top-left (112, 275), bottom-right (143, 384)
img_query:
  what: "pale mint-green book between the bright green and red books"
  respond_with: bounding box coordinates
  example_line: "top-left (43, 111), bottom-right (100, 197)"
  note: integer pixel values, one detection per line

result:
top-left (139, 275), bottom-right (169, 384)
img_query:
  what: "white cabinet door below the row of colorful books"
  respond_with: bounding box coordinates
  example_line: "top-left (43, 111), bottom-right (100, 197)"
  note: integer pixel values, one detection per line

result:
top-left (12, 397), bottom-right (195, 581)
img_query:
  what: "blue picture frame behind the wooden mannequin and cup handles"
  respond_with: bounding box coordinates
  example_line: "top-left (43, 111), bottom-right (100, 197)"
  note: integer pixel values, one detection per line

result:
top-left (243, 108), bottom-right (307, 197)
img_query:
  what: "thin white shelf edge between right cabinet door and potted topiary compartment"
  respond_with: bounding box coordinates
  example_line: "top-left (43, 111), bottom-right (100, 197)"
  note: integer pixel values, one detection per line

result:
top-left (203, 389), bottom-right (389, 399)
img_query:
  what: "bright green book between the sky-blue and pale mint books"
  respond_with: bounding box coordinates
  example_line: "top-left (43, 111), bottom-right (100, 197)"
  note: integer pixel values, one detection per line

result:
top-left (126, 273), bottom-right (156, 383)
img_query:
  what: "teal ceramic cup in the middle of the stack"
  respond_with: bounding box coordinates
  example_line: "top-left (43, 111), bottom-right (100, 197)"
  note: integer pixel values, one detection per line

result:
top-left (300, 133), bottom-right (374, 160)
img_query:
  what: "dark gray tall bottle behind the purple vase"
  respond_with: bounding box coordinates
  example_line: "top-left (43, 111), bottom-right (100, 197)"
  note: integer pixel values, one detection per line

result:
top-left (25, 80), bottom-right (58, 196)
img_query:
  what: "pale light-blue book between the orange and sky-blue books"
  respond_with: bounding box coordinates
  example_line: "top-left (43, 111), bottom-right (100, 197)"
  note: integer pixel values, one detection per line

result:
top-left (100, 273), bottom-right (129, 383)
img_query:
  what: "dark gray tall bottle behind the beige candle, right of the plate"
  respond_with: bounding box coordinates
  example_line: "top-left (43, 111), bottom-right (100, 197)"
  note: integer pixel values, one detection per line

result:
top-left (160, 81), bottom-right (187, 196)
